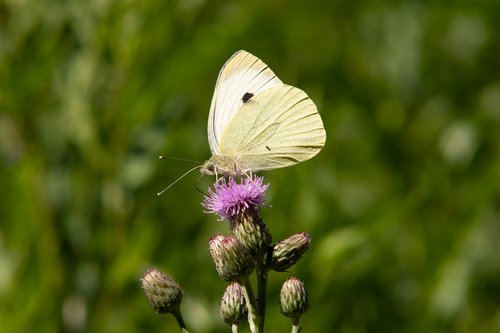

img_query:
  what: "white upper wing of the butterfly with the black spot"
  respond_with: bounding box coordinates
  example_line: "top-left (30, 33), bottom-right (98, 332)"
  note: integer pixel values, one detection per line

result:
top-left (208, 50), bottom-right (283, 155)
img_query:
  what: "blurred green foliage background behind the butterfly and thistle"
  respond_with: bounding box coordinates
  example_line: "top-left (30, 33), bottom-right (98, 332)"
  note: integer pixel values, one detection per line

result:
top-left (0, 0), bottom-right (500, 333)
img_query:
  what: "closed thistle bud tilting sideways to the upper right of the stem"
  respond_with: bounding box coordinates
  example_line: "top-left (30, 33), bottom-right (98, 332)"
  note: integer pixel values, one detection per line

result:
top-left (271, 232), bottom-right (311, 272)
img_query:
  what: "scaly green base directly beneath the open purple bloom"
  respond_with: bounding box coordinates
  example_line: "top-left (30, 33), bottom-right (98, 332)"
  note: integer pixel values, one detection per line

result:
top-left (231, 210), bottom-right (271, 257)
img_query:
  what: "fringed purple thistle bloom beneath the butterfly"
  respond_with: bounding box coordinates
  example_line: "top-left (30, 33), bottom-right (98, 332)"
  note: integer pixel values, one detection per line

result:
top-left (202, 177), bottom-right (269, 221)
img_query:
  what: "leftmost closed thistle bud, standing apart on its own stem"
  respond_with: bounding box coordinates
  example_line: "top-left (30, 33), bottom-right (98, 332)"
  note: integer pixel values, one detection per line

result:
top-left (141, 268), bottom-right (182, 314)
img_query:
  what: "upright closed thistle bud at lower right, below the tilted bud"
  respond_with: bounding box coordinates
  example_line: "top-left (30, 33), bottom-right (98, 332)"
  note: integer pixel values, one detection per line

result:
top-left (280, 277), bottom-right (309, 322)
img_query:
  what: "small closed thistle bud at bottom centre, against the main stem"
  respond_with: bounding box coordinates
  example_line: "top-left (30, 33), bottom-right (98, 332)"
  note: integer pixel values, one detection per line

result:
top-left (219, 282), bottom-right (248, 325)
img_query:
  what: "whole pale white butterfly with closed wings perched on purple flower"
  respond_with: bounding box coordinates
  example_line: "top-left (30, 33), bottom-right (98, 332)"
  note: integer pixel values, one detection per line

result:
top-left (201, 51), bottom-right (326, 176)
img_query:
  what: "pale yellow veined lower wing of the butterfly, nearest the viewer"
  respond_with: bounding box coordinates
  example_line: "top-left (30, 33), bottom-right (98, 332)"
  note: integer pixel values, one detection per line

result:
top-left (219, 85), bottom-right (326, 171)
